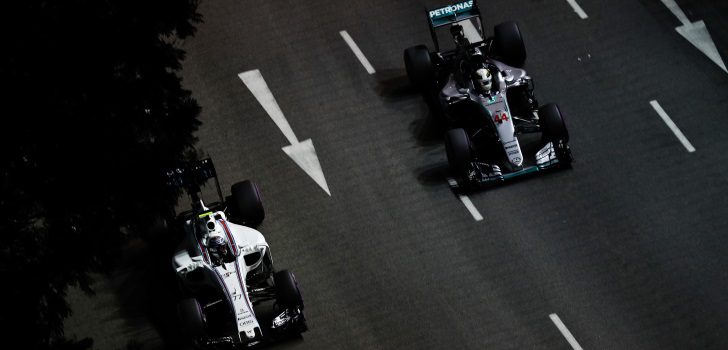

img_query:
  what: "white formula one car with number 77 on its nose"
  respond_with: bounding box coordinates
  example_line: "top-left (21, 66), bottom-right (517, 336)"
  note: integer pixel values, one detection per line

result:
top-left (168, 159), bottom-right (307, 349)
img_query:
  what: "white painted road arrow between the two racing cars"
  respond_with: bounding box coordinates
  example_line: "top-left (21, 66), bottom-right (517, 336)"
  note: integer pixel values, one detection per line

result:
top-left (238, 69), bottom-right (331, 196)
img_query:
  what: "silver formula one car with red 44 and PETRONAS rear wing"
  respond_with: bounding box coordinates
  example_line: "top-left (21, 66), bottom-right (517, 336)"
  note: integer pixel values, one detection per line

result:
top-left (404, 0), bottom-right (572, 188)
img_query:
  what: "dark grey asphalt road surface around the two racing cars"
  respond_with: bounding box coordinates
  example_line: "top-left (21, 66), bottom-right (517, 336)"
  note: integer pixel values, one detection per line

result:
top-left (67, 0), bottom-right (728, 349)
